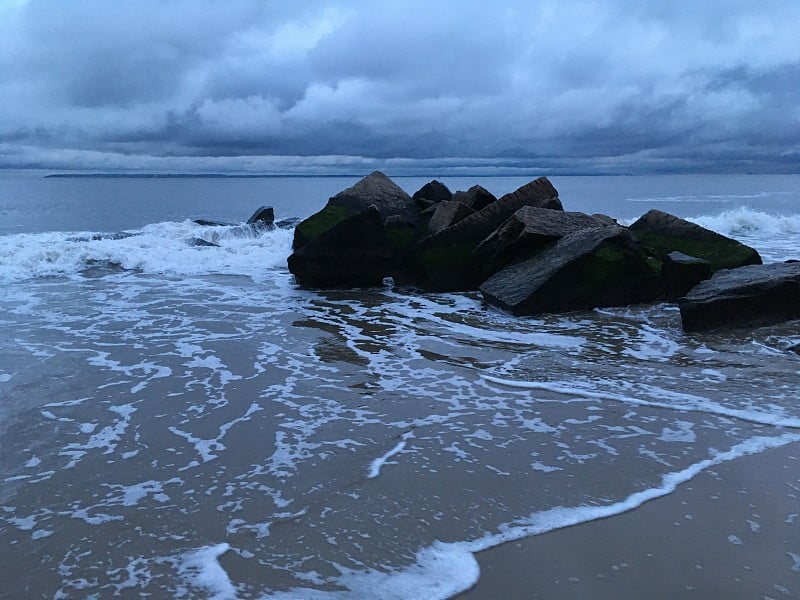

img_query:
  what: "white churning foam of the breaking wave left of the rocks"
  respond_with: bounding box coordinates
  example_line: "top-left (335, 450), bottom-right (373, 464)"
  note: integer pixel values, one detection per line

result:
top-left (0, 221), bottom-right (293, 281)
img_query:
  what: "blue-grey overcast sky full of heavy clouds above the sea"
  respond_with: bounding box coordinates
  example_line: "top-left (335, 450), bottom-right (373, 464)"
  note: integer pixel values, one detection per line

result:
top-left (0, 0), bottom-right (800, 174)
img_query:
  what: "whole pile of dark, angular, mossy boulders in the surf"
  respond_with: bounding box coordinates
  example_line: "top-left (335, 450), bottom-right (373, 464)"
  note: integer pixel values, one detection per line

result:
top-left (288, 171), bottom-right (800, 331)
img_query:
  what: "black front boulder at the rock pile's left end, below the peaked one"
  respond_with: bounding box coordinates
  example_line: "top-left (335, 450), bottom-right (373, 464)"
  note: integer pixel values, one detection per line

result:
top-left (288, 206), bottom-right (395, 287)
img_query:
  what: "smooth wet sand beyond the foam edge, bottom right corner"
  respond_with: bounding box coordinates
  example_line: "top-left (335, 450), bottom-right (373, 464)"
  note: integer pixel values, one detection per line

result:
top-left (458, 444), bottom-right (800, 600)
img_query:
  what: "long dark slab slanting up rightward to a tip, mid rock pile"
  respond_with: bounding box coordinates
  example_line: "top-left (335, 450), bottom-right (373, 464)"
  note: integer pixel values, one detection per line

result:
top-left (405, 177), bottom-right (561, 291)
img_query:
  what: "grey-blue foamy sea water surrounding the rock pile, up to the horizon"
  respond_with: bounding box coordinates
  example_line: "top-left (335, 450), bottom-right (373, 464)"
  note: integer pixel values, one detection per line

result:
top-left (0, 172), bottom-right (800, 599)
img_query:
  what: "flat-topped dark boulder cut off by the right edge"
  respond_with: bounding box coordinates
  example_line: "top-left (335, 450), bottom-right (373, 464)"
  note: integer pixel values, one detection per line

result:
top-left (678, 263), bottom-right (800, 331)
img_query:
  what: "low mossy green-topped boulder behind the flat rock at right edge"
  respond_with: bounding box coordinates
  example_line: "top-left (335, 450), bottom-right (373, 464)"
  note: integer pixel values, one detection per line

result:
top-left (630, 209), bottom-right (761, 272)
